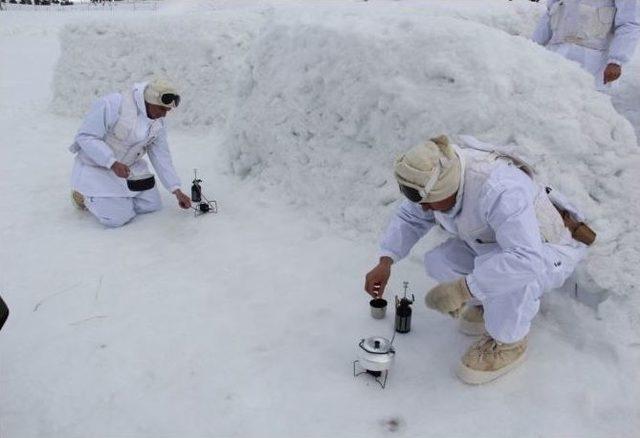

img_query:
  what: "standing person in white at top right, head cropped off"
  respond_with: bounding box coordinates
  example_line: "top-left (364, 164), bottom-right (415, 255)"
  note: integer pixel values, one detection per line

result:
top-left (533, 0), bottom-right (640, 90)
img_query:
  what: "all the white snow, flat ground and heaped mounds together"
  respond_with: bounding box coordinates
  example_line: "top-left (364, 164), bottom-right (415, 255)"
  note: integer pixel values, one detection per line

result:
top-left (0, 0), bottom-right (640, 438)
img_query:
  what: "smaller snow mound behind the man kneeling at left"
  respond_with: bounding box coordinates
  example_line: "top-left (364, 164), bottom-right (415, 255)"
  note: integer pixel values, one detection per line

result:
top-left (53, 13), bottom-right (260, 128)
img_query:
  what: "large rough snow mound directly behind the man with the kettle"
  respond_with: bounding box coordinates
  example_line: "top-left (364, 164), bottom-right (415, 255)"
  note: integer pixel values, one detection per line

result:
top-left (229, 13), bottom-right (639, 300)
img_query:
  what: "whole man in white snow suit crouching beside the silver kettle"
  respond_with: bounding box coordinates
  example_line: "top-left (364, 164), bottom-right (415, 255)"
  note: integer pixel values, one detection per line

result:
top-left (365, 136), bottom-right (590, 384)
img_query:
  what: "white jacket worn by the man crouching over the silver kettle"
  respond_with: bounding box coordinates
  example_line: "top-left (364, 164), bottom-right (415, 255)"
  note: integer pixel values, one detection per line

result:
top-left (380, 139), bottom-right (573, 302)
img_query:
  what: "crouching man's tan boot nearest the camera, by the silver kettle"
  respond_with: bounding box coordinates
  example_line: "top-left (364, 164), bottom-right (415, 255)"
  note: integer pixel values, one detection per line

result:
top-left (456, 336), bottom-right (527, 385)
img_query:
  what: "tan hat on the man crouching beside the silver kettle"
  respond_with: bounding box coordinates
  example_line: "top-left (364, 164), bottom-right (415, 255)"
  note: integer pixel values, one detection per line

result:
top-left (394, 135), bottom-right (461, 202)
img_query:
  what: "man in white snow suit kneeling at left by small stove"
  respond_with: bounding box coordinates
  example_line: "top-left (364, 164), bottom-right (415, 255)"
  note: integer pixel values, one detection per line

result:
top-left (69, 79), bottom-right (191, 227)
